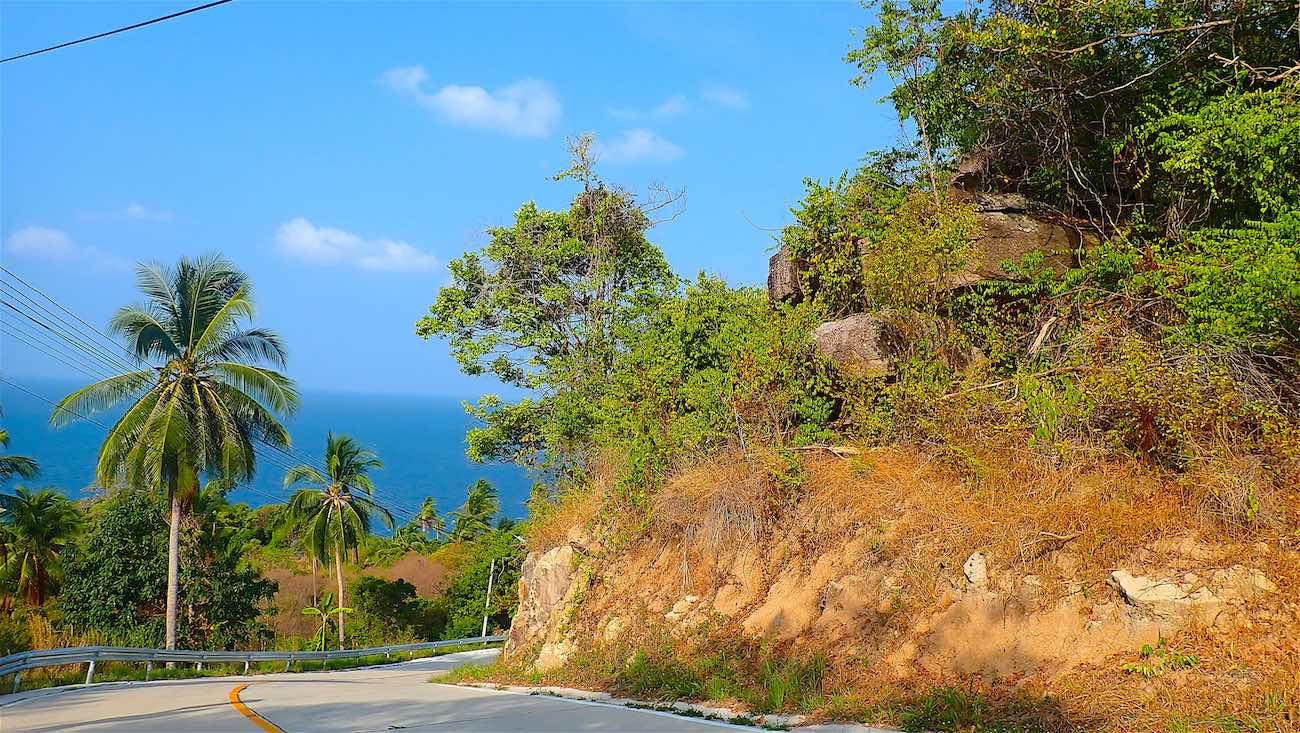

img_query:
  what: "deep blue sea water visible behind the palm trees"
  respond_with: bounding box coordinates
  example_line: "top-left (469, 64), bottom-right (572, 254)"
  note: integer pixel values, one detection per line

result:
top-left (0, 374), bottom-right (530, 524)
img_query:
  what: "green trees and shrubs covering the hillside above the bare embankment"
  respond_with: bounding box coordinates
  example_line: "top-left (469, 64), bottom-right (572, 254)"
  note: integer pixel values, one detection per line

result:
top-left (417, 0), bottom-right (1300, 526)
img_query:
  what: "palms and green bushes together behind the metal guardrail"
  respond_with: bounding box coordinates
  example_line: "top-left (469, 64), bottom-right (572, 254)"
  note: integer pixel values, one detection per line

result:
top-left (0, 256), bottom-right (521, 654)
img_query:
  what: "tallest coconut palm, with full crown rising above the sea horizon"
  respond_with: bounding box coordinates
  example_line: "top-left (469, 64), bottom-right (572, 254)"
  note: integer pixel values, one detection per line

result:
top-left (49, 256), bottom-right (298, 649)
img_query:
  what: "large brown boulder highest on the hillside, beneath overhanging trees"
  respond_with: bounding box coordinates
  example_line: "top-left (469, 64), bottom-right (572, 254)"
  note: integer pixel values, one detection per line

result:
top-left (948, 192), bottom-right (1096, 287)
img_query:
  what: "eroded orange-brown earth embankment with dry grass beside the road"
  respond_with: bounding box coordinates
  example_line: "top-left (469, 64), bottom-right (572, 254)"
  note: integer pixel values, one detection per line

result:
top-left (498, 448), bottom-right (1300, 730)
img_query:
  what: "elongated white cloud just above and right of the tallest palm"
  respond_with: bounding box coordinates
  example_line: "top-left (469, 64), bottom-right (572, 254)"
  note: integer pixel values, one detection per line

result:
top-left (276, 217), bottom-right (441, 272)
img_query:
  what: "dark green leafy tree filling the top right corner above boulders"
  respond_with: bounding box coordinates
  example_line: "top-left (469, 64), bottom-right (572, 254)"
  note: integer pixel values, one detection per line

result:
top-left (849, 0), bottom-right (1300, 231)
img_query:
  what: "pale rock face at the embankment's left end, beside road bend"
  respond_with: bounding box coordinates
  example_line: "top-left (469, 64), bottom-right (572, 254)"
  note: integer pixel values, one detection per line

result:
top-left (506, 545), bottom-right (573, 668)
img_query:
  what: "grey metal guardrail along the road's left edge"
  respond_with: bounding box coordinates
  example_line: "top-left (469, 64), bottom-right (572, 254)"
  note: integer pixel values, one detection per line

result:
top-left (0, 636), bottom-right (506, 693)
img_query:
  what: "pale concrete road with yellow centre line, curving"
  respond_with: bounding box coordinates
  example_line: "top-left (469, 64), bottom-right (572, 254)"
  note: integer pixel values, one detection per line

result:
top-left (0, 650), bottom-right (759, 733)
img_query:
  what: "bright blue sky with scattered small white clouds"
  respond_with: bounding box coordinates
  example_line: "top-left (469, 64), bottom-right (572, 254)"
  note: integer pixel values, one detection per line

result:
top-left (0, 0), bottom-right (898, 396)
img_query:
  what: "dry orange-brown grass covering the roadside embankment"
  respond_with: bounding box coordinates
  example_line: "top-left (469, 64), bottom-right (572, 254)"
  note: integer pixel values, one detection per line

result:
top-left (499, 435), bottom-right (1300, 733)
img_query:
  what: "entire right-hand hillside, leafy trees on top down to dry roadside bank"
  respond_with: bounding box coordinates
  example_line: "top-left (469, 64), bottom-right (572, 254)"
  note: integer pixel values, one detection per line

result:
top-left (417, 0), bottom-right (1300, 732)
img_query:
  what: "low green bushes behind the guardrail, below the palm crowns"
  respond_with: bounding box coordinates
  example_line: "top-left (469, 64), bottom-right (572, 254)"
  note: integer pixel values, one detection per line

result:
top-left (0, 467), bottom-right (521, 654)
